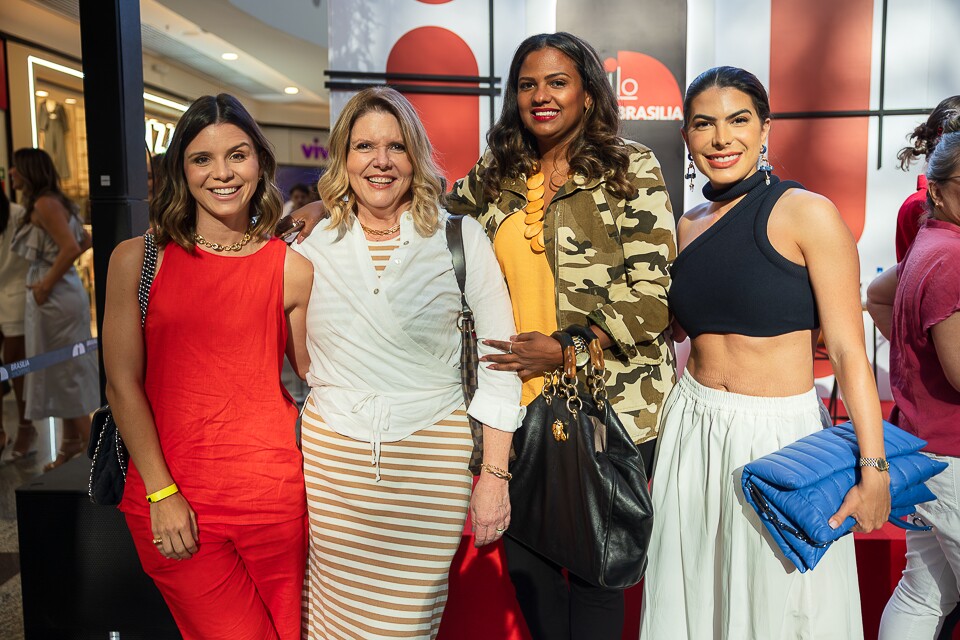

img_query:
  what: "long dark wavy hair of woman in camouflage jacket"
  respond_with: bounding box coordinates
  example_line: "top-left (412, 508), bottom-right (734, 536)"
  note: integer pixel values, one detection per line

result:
top-left (483, 31), bottom-right (636, 200)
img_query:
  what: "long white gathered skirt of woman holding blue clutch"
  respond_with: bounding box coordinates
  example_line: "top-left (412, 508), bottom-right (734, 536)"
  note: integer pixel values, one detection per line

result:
top-left (640, 374), bottom-right (863, 640)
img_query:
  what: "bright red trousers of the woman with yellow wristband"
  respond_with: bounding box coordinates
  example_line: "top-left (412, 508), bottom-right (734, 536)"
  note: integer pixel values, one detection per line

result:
top-left (126, 514), bottom-right (307, 640)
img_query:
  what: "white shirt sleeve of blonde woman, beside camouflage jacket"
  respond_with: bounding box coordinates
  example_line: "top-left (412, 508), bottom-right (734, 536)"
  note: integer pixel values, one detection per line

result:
top-left (463, 217), bottom-right (526, 432)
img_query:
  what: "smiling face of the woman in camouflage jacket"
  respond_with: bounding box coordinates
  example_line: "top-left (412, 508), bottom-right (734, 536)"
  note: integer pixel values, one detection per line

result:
top-left (517, 47), bottom-right (593, 153)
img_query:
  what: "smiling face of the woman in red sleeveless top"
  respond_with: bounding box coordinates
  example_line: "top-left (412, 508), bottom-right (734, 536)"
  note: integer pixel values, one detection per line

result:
top-left (183, 123), bottom-right (260, 224)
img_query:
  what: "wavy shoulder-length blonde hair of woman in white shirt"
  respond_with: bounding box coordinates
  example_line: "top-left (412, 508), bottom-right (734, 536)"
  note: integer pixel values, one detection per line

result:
top-left (317, 87), bottom-right (447, 238)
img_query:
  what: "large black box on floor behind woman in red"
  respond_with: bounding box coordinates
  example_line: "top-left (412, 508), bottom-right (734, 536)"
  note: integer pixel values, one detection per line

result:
top-left (17, 456), bottom-right (181, 640)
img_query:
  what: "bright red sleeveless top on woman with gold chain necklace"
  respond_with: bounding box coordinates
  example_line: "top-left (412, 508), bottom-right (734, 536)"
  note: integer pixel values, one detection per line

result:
top-left (120, 239), bottom-right (306, 525)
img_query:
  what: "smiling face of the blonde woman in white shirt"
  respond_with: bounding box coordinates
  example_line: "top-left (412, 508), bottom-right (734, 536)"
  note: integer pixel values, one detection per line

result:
top-left (347, 111), bottom-right (413, 222)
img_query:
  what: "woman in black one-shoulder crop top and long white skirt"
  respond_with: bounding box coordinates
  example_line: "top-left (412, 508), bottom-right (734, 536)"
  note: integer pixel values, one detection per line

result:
top-left (640, 67), bottom-right (890, 640)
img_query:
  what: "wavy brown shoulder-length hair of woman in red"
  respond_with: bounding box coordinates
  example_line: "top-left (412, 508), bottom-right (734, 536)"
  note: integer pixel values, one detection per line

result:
top-left (150, 93), bottom-right (283, 251)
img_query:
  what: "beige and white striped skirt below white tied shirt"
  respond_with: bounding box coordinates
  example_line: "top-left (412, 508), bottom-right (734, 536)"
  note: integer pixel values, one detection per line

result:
top-left (302, 399), bottom-right (473, 640)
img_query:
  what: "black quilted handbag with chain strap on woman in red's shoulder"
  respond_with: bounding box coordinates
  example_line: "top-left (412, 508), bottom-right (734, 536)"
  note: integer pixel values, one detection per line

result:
top-left (87, 233), bottom-right (157, 506)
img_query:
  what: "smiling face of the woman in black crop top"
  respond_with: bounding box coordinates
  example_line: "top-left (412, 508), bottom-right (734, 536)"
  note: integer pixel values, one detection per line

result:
top-left (682, 87), bottom-right (770, 187)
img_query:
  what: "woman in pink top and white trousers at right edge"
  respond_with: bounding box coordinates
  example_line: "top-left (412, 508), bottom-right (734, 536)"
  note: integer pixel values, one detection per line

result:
top-left (868, 116), bottom-right (960, 640)
